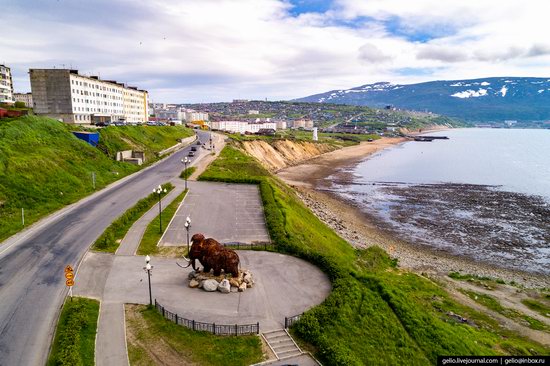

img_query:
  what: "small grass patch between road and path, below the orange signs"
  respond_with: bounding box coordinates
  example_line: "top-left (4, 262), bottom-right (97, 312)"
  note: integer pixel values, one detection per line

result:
top-left (47, 297), bottom-right (99, 366)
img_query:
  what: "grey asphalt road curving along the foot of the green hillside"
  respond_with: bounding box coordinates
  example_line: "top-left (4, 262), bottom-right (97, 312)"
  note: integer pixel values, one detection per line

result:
top-left (0, 131), bottom-right (209, 366)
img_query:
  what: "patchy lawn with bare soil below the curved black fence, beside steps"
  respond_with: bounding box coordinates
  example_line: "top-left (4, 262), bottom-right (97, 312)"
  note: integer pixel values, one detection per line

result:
top-left (126, 305), bottom-right (262, 366)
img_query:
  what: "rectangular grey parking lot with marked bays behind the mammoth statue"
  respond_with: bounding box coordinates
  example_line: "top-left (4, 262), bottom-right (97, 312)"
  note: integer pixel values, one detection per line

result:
top-left (159, 182), bottom-right (270, 246)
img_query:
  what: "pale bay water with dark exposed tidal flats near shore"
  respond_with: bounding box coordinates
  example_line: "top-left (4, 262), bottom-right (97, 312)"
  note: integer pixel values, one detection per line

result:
top-left (328, 128), bottom-right (550, 274)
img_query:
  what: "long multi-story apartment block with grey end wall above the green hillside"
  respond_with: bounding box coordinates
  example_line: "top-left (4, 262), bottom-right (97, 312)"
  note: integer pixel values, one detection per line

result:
top-left (29, 69), bottom-right (148, 124)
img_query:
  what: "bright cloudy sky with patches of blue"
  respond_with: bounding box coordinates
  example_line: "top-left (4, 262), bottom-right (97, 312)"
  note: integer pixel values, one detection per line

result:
top-left (0, 0), bottom-right (550, 103)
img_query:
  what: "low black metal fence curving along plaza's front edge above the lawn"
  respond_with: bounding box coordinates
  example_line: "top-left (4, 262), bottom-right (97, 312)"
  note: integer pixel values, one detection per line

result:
top-left (155, 299), bottom-right (260, 336)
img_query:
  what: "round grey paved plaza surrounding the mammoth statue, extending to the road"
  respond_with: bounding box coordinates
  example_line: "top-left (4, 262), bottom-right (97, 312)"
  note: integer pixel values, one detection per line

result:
top-left (74, 251), bottom-right (331, 332)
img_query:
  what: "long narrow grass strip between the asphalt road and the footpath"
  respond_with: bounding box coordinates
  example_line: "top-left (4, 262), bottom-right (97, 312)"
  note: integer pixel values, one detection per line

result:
top-left (92, 183), bottom-right (174, 253)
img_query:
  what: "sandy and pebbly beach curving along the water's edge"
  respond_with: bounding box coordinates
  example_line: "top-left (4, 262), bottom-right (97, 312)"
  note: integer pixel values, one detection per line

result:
top-left (276, 138), bottom-right (550, 288)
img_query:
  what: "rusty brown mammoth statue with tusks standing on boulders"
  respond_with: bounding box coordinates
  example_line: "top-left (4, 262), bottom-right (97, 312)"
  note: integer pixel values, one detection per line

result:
top-left (181, 234), bottom-right (239, 277)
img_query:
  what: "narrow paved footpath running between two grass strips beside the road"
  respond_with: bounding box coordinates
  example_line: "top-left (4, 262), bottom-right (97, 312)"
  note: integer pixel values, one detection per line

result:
top-left (116, 185), bottom-right (184, 255)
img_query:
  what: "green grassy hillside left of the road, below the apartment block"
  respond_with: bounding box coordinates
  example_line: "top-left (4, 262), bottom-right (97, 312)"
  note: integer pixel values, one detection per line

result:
top-left (0, 116), bottom-right (193, 241)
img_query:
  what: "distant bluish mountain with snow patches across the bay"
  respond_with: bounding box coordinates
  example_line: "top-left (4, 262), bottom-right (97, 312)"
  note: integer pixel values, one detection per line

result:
top-left (295, 77), bottom-right (550, 122)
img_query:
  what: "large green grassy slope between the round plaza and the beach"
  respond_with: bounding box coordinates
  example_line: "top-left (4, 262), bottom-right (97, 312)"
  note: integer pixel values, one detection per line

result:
top-left (200, 146), bottom-right (550, 365)
